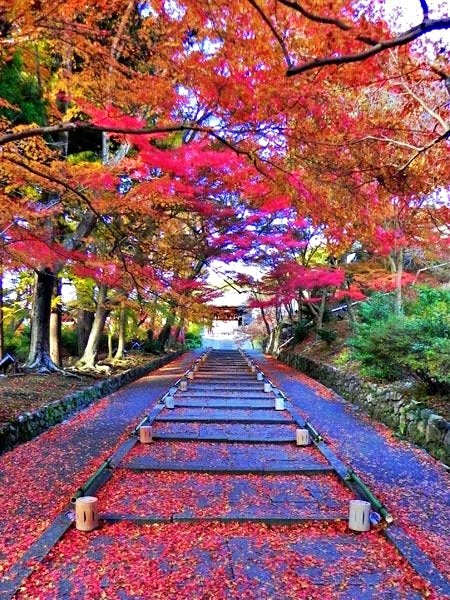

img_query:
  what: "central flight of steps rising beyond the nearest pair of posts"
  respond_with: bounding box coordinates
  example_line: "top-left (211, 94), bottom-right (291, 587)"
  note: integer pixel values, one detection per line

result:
top-left (100, 350), bottom-right (355, 524)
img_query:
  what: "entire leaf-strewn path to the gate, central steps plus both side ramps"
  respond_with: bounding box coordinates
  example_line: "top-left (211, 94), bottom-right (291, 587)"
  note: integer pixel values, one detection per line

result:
top-left (0, 351), bottom-right (448, 600)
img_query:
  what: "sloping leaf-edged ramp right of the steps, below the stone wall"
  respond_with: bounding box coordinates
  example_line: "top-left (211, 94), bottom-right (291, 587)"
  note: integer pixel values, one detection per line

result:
top-left (258, 356), bottom-right (450, 580)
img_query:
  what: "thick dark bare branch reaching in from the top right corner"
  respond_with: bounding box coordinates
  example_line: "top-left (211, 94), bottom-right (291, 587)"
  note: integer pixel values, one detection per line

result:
top-left (288, 17), bottom-right (450, 77)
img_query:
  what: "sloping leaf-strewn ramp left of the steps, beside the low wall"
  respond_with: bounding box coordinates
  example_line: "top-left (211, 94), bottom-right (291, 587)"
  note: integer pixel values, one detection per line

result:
top-left (0, 353), bottom-right (193, 590)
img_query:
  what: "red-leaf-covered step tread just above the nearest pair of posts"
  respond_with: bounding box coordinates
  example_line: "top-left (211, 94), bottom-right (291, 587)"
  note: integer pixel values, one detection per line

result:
top-left (98, 469), bottom-right (354, 518)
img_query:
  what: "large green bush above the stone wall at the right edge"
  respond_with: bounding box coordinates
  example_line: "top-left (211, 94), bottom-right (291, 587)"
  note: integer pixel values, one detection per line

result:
top-left (349, 287), bottom-right (450, 392)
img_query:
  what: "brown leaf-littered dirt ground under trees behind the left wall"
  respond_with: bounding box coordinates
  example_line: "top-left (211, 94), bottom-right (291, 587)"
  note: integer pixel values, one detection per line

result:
top-left (0, 354), bottom-right (155, 425)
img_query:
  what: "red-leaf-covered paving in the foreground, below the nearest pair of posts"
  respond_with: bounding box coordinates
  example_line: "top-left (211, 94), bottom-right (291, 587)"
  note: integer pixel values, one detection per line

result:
top-left (17, 523), bottom-right (433, 600)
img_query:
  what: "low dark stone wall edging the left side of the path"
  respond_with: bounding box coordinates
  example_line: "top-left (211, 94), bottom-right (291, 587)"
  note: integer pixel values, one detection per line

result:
top-left (0, 351), bottom-right (182, 453)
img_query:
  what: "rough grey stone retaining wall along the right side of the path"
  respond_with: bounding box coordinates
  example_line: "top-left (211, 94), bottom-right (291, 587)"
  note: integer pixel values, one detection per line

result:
top-left (279, 352), bottom-right (450, 465)
